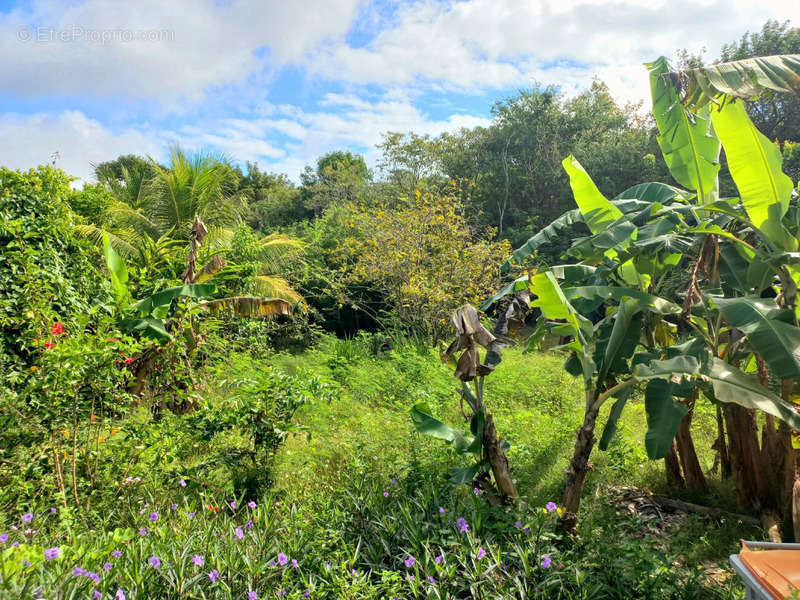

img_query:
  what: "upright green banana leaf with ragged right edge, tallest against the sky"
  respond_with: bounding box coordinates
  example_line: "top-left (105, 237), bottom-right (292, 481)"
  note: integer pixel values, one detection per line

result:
top-left (647, 56), bottom-right (720, 204)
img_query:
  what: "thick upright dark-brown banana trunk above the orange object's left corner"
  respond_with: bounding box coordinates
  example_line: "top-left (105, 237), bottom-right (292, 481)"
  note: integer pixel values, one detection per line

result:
top-left (724, 404), bottom-right (763, 510)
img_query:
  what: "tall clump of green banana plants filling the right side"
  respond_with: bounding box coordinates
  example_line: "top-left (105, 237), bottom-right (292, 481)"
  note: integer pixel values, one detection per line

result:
top-left (485, 55), bottom-right (800, 537)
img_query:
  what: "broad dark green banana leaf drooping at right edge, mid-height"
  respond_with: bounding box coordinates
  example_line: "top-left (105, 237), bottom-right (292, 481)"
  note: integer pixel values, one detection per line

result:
top-left (714, 298), bottom-right (800, 379)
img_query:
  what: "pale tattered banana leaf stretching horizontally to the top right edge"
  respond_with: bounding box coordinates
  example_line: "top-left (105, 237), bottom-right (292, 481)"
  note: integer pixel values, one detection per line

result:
top-left (675, 54), bottom-right (800, 107)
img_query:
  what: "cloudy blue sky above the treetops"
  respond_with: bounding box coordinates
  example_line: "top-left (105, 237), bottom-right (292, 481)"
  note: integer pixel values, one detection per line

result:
top-left (0, 0), bottom-right (800, 182)
